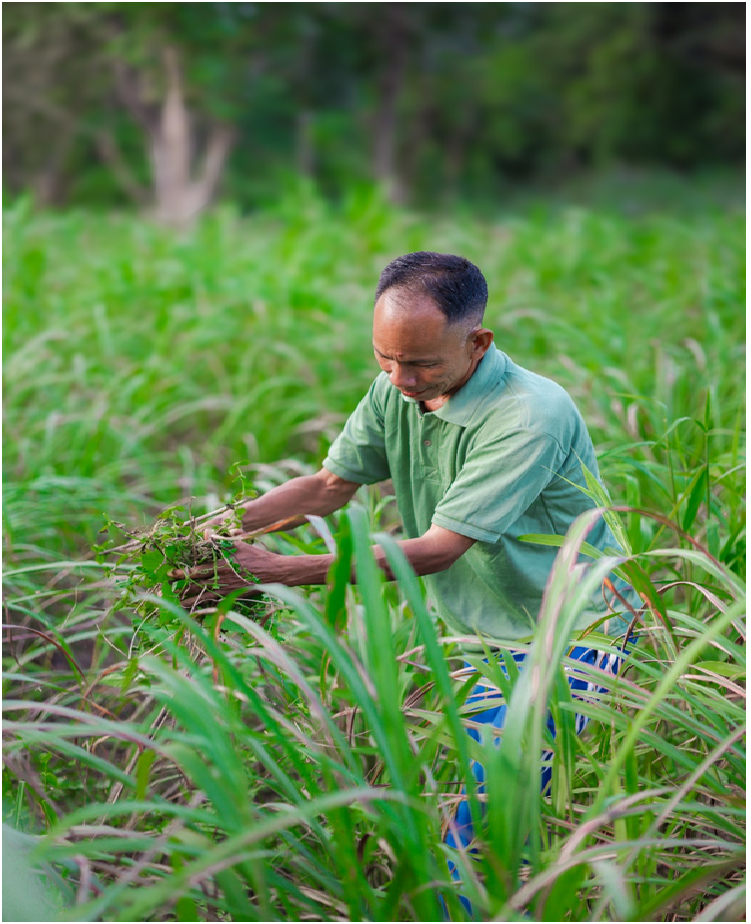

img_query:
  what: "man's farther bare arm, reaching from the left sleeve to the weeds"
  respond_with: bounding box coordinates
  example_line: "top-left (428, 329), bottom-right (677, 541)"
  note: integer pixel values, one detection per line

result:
top-left (205, 468), bottom-right (360, 533)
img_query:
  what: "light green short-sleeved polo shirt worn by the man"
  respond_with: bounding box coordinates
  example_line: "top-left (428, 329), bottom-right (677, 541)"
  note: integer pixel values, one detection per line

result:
top-left (323, 345), bottom-right (620, 642)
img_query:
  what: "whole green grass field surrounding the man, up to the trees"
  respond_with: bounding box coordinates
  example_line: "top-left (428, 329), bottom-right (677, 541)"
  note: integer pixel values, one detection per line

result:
top-left (3, 179), bottom-right (745, 921)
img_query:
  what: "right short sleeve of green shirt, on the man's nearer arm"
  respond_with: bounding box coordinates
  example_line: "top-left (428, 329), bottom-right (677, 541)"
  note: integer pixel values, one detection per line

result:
top-left (432, 428), bottom-right (564, 542)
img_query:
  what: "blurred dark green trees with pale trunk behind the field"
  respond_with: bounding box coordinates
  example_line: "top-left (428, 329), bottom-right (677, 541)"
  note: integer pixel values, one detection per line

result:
top-left (3, 3), bottom-right (745, 224)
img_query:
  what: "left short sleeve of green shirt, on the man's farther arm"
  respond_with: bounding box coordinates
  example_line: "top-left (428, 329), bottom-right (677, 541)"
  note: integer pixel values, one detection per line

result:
top-left (323, 376), bottom-right (391, 484)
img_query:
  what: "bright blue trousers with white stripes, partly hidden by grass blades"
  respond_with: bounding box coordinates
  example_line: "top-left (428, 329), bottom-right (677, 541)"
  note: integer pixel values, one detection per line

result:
top-left (444, 639), bottom-right (633, 913)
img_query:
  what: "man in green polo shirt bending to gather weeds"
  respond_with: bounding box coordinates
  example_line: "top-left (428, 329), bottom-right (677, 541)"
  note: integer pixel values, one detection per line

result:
top-left (191, 252), bottom-right (623, 896)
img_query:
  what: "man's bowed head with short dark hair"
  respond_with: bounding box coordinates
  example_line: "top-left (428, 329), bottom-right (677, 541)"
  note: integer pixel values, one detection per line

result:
top-left (373, 252), bottom-right (493, 406)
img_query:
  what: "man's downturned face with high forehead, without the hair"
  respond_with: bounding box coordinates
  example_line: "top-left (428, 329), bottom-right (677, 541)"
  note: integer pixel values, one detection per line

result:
top-left (373, 288), bottom-right (493, 401)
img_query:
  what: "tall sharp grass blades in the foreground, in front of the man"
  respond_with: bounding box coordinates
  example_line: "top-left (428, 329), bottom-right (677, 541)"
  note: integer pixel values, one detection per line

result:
top-left (3, 508), bottom-right (745, 921)
